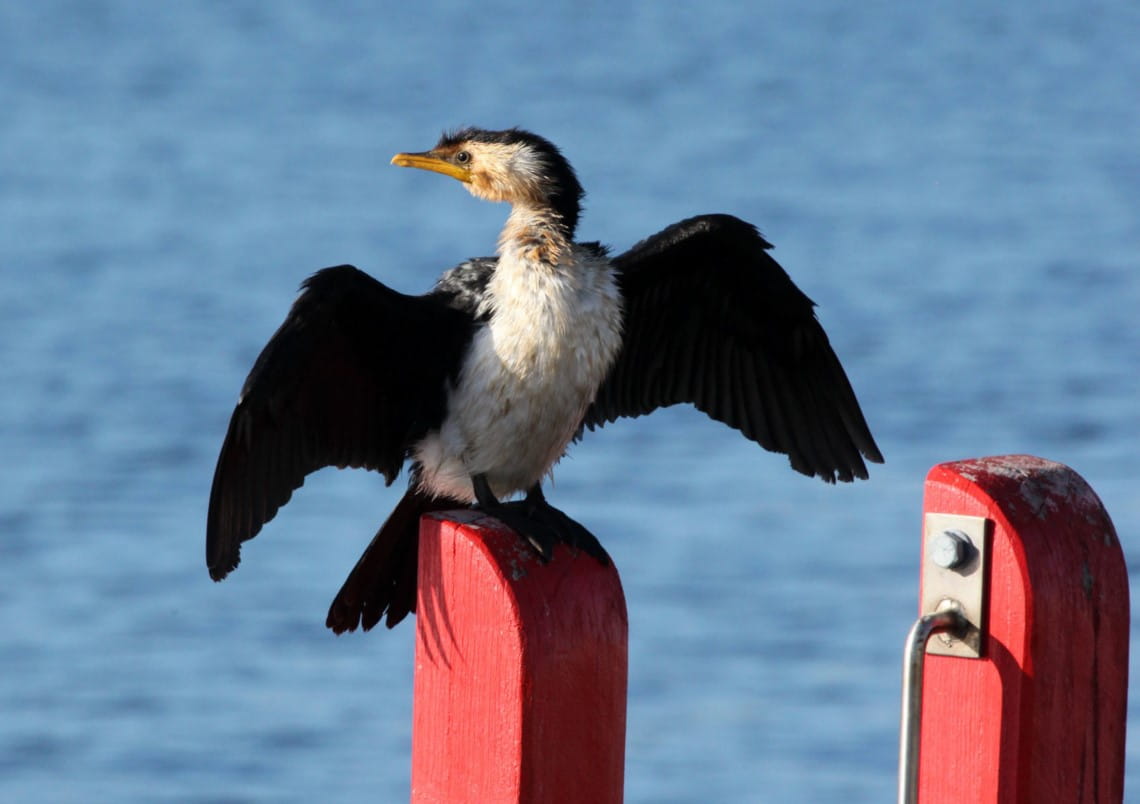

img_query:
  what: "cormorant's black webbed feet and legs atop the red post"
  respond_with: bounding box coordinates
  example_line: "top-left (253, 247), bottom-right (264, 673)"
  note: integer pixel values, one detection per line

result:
top-left (472, 474), bottom-right (610, 566)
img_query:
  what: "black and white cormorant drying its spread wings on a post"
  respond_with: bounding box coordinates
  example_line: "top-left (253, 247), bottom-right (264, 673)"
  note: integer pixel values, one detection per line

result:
top-left (206, 129), bottom-right (882, 633)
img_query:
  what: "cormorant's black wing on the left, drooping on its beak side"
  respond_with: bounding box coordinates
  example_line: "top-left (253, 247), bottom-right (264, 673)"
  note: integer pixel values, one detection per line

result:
top-left (206, 266), bottom-right (474, 580)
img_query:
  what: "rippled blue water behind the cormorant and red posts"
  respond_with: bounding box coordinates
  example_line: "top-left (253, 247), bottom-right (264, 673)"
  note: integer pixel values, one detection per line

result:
top-left (0, 0), bottom-right (1140, 802)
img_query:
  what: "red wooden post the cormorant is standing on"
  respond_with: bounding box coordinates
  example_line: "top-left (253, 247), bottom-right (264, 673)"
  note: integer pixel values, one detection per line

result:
top-left (412, 512), bottom-right (628, 804)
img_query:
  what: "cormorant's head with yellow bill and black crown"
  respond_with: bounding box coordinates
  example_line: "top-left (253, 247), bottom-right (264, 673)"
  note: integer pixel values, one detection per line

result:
top-left (392, 129), bottom-right (584, 237)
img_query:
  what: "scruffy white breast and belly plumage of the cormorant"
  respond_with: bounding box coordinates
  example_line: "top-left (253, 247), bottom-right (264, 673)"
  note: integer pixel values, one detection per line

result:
top-left (416, 241), bottom-right (621, 500)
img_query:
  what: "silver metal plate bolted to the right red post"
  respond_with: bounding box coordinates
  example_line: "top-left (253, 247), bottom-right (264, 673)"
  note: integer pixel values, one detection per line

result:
top-left (921, 513), bottom-right (992, 659)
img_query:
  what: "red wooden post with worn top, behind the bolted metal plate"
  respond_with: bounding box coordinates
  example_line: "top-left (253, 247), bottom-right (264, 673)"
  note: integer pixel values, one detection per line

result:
top-left (919, 455), bottom-right (1129, 804)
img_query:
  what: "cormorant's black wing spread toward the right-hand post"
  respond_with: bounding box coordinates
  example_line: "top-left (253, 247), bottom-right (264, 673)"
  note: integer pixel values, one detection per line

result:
top-left (583, 209), bottom-right (882, 482)
